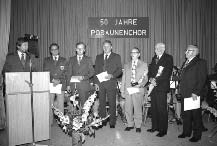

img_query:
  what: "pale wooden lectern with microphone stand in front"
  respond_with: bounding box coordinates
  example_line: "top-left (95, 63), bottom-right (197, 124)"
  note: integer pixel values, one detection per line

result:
top-left (5, 72), bottom-right (51, 146)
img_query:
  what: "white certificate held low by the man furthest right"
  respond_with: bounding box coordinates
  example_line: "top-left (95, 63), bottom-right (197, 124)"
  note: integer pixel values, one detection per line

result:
top-left (184, 96), bottom-right (200, 111)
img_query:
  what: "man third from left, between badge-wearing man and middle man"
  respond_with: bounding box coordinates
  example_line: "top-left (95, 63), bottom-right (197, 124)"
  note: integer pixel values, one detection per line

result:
top-left (67, 42), bottom-right (94, 106)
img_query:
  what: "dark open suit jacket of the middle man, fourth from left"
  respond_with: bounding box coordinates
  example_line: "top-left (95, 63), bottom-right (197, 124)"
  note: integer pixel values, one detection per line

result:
top-left (94, 52), bottom-right (122, 84)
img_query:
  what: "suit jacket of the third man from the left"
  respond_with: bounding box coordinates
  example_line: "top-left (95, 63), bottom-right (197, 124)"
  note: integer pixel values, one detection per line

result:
top-left (67, 55), bottom-right (94, 91)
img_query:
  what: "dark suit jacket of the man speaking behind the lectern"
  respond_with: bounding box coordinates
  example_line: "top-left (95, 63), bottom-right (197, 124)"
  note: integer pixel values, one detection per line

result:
top-left (2, 52), bottom-right (37, 74)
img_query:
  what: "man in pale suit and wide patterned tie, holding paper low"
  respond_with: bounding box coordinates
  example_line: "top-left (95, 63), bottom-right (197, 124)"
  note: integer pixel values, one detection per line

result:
top-left (121, 47), bottom-right (148, 133)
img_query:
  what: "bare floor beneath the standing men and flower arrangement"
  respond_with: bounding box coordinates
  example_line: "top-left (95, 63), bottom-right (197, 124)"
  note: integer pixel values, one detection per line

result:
top-left (0, 116), bottom-right (217, 146)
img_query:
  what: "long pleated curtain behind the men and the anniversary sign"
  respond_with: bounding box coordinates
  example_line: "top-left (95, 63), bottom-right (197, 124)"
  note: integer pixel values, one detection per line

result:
top-left (7, 0), bottom-right (217, 72)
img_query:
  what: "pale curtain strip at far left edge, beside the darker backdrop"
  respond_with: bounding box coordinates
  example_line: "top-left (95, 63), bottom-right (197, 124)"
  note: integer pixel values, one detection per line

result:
top-left (0, 0), bottom-right (11, 73)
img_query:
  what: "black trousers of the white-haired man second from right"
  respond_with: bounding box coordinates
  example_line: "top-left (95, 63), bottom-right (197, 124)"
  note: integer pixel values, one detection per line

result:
top-left (151, 91), bottom-right (168, 133)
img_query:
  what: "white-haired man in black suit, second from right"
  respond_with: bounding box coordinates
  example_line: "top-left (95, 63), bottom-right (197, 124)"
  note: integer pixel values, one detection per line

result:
top-left (147, 43), bottom-right (173, 137)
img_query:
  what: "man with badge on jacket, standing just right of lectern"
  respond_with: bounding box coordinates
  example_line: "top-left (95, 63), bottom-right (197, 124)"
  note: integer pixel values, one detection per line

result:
top-left (43, 43), bottom-right (67, 125)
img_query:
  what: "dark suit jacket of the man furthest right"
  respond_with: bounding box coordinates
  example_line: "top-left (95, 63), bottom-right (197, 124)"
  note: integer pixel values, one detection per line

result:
top-left (180, 57), bottom-right (207, 98)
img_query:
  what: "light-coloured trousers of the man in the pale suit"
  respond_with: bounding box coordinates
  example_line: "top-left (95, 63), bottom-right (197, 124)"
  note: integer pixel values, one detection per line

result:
top-left (125, 93), bottom-right (143, 128)
